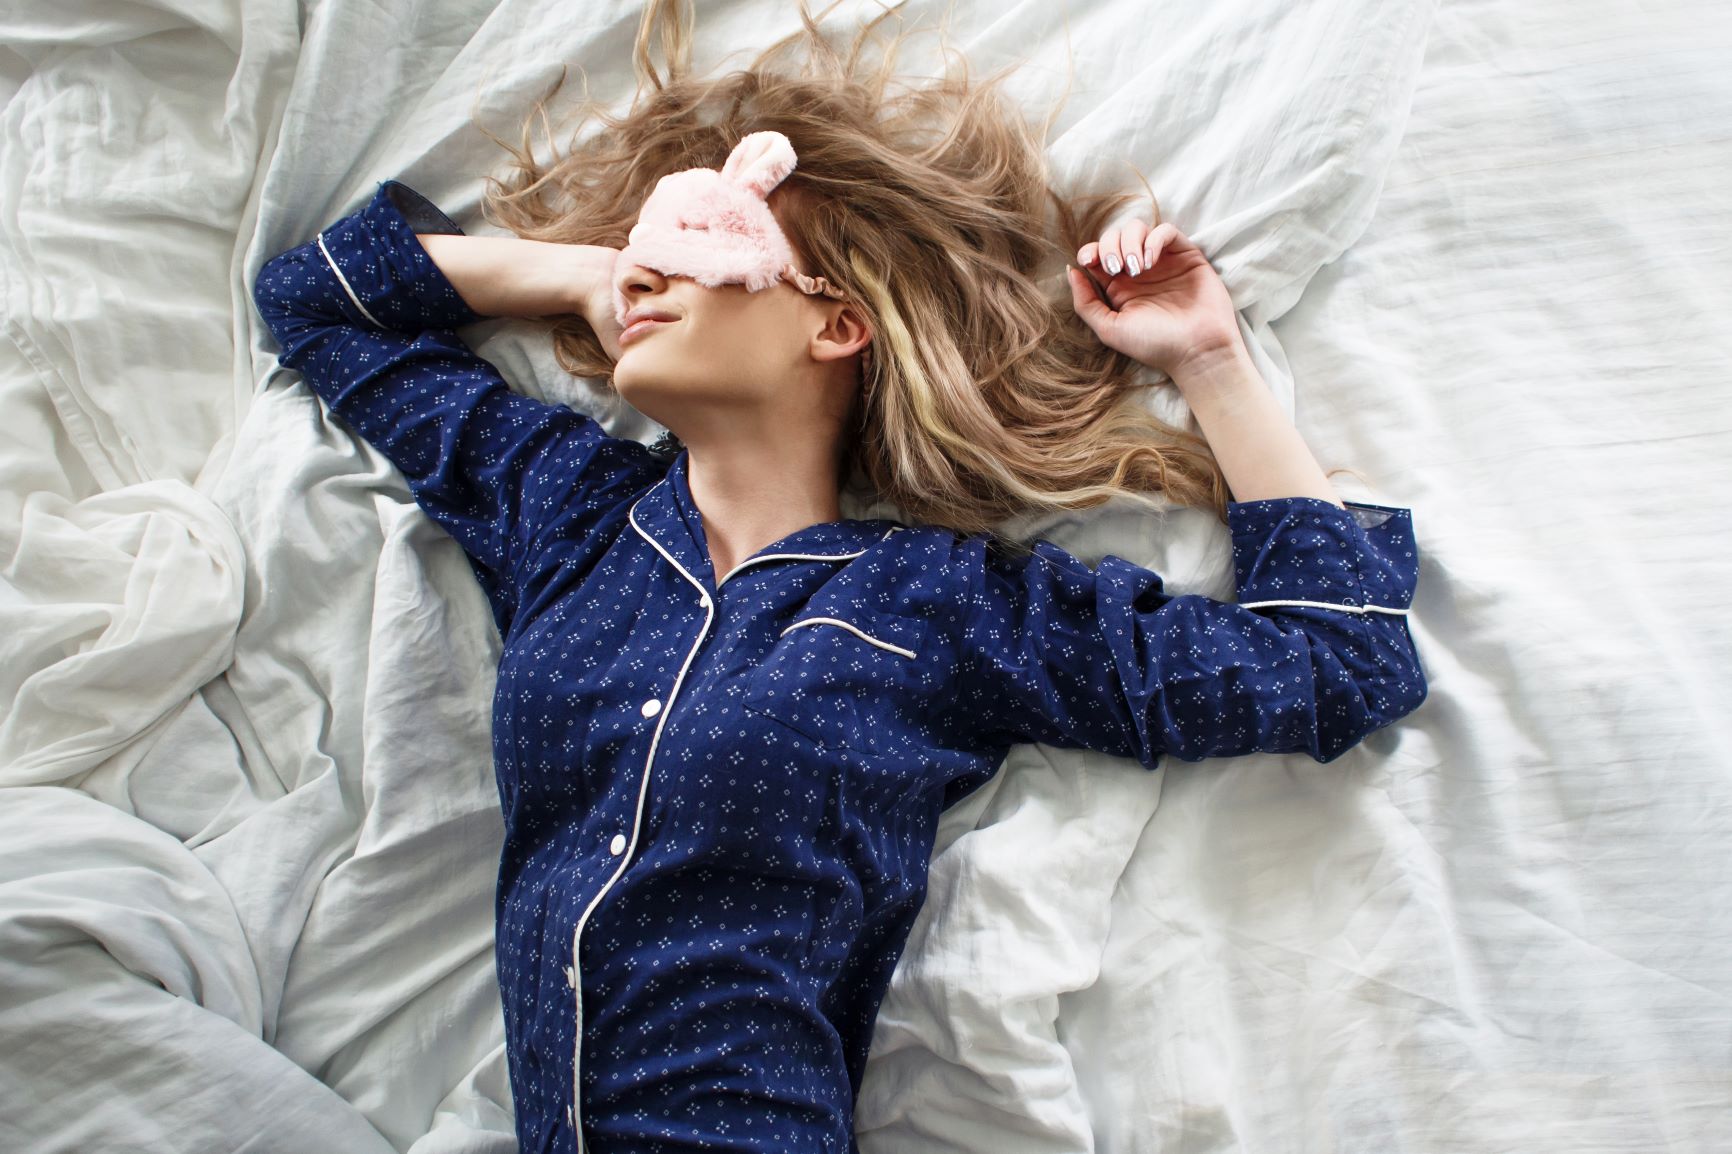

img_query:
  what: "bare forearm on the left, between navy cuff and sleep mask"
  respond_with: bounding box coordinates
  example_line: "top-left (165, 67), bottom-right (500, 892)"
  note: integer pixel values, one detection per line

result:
top-left (416, 232), bottom-right (587, 317)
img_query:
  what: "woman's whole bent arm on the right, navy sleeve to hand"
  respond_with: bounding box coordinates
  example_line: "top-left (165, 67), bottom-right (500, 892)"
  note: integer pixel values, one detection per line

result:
top-left (951, 225), bottom-right (1425, 768)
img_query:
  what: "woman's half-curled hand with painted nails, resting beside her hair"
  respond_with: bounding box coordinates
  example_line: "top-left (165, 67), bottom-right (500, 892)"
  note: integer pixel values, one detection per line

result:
top-left (1065, 220), bottom-right (1242, 376)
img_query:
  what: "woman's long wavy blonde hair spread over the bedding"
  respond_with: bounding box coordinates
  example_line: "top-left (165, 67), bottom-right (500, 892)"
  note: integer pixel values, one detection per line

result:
top-left (481, 0), bottom-right (1228, 549)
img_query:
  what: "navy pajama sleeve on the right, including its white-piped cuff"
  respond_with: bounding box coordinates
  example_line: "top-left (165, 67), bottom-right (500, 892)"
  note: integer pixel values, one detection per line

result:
top-left (954, 497), bottom-right (1425, 769)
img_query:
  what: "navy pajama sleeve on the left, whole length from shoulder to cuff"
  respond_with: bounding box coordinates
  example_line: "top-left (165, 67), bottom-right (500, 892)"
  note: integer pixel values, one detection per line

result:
top-left (253, 180), bottom-right (648, 632)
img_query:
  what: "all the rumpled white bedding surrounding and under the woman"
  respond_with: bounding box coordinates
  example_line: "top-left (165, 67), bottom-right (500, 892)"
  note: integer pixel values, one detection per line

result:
top-left (0, 0), bottom-right (1732, 1154)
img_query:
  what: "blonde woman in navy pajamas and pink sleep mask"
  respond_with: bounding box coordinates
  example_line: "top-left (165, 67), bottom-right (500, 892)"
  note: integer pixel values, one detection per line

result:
top-left (256, 9), bottom-right (1425, 1152)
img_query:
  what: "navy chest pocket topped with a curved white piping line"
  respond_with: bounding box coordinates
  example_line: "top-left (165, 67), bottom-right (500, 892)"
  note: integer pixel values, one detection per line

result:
top-left (741, 605), bottom-right (937, 752)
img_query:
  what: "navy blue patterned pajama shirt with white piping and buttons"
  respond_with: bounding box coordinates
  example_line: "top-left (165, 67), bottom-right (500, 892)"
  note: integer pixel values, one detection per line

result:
top-left (255, 180), bottom-right (1425, 1154)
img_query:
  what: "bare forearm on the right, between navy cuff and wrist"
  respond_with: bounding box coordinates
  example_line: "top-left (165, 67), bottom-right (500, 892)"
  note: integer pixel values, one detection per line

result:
top-left (1173, 343), bottom-right (1342, 506)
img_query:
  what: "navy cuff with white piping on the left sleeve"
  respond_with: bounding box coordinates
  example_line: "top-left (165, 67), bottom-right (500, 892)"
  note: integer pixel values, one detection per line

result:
top-left (319, 180), bottom-right (487, 333)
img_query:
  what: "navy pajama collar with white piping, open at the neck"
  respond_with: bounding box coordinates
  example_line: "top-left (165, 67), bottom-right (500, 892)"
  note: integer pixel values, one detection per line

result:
top-left (630, 449), bottom-right (902, 594)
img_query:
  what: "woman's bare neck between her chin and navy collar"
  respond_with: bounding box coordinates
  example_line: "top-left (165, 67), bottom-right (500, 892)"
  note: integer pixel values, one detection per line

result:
top-left (686, 433), bottom-right (842, 580)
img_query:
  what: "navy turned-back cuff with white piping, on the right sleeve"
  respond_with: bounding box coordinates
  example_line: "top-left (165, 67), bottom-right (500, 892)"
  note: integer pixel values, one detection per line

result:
top-left (1226, 497), bottom-right (1419, 613)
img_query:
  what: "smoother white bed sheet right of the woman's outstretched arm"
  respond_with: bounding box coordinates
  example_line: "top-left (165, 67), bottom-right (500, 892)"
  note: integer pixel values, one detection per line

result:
top-left (1011, 2), bottom-right (1732, 1154)
